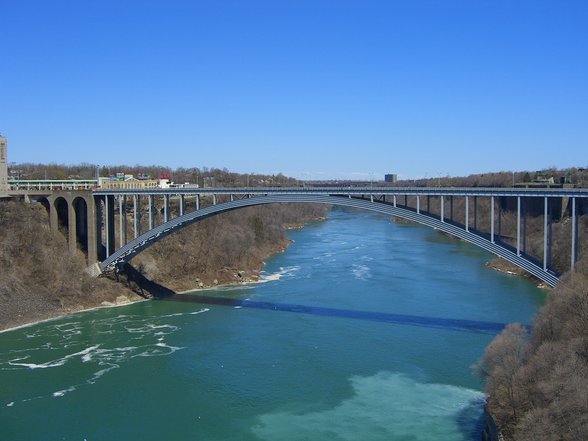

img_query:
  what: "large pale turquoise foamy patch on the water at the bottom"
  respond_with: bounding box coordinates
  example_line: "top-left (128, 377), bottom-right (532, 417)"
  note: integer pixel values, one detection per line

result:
top-left (252, 372), bottom-right (484, 441)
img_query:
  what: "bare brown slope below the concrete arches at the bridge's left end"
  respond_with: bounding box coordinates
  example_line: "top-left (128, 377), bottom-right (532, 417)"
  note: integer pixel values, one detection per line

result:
top-left (0, 201), bottom-right (135, 329)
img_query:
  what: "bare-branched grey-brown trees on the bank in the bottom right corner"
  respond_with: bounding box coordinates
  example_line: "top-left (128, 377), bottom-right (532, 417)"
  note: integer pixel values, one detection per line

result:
top-left (476, 258), bottom-right (588, 441)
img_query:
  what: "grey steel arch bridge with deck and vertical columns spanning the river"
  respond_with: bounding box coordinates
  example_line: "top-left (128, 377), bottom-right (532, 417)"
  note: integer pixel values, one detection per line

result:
top-left (88, 187), bottom-right (588, 286)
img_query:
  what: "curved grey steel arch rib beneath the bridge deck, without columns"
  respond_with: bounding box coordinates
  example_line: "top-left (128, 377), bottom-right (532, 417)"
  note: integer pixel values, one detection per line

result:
top-left (100, 194), bottom-right (559, 286)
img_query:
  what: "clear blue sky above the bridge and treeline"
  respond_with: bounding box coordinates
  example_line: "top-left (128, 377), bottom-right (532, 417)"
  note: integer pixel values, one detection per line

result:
top-left (0, 0), bottom-right (588, 179)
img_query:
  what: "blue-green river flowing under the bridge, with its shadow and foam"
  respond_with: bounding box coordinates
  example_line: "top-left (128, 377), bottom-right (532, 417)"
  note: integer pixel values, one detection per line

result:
top-left (0, 210), bottom-right (544, 441)
